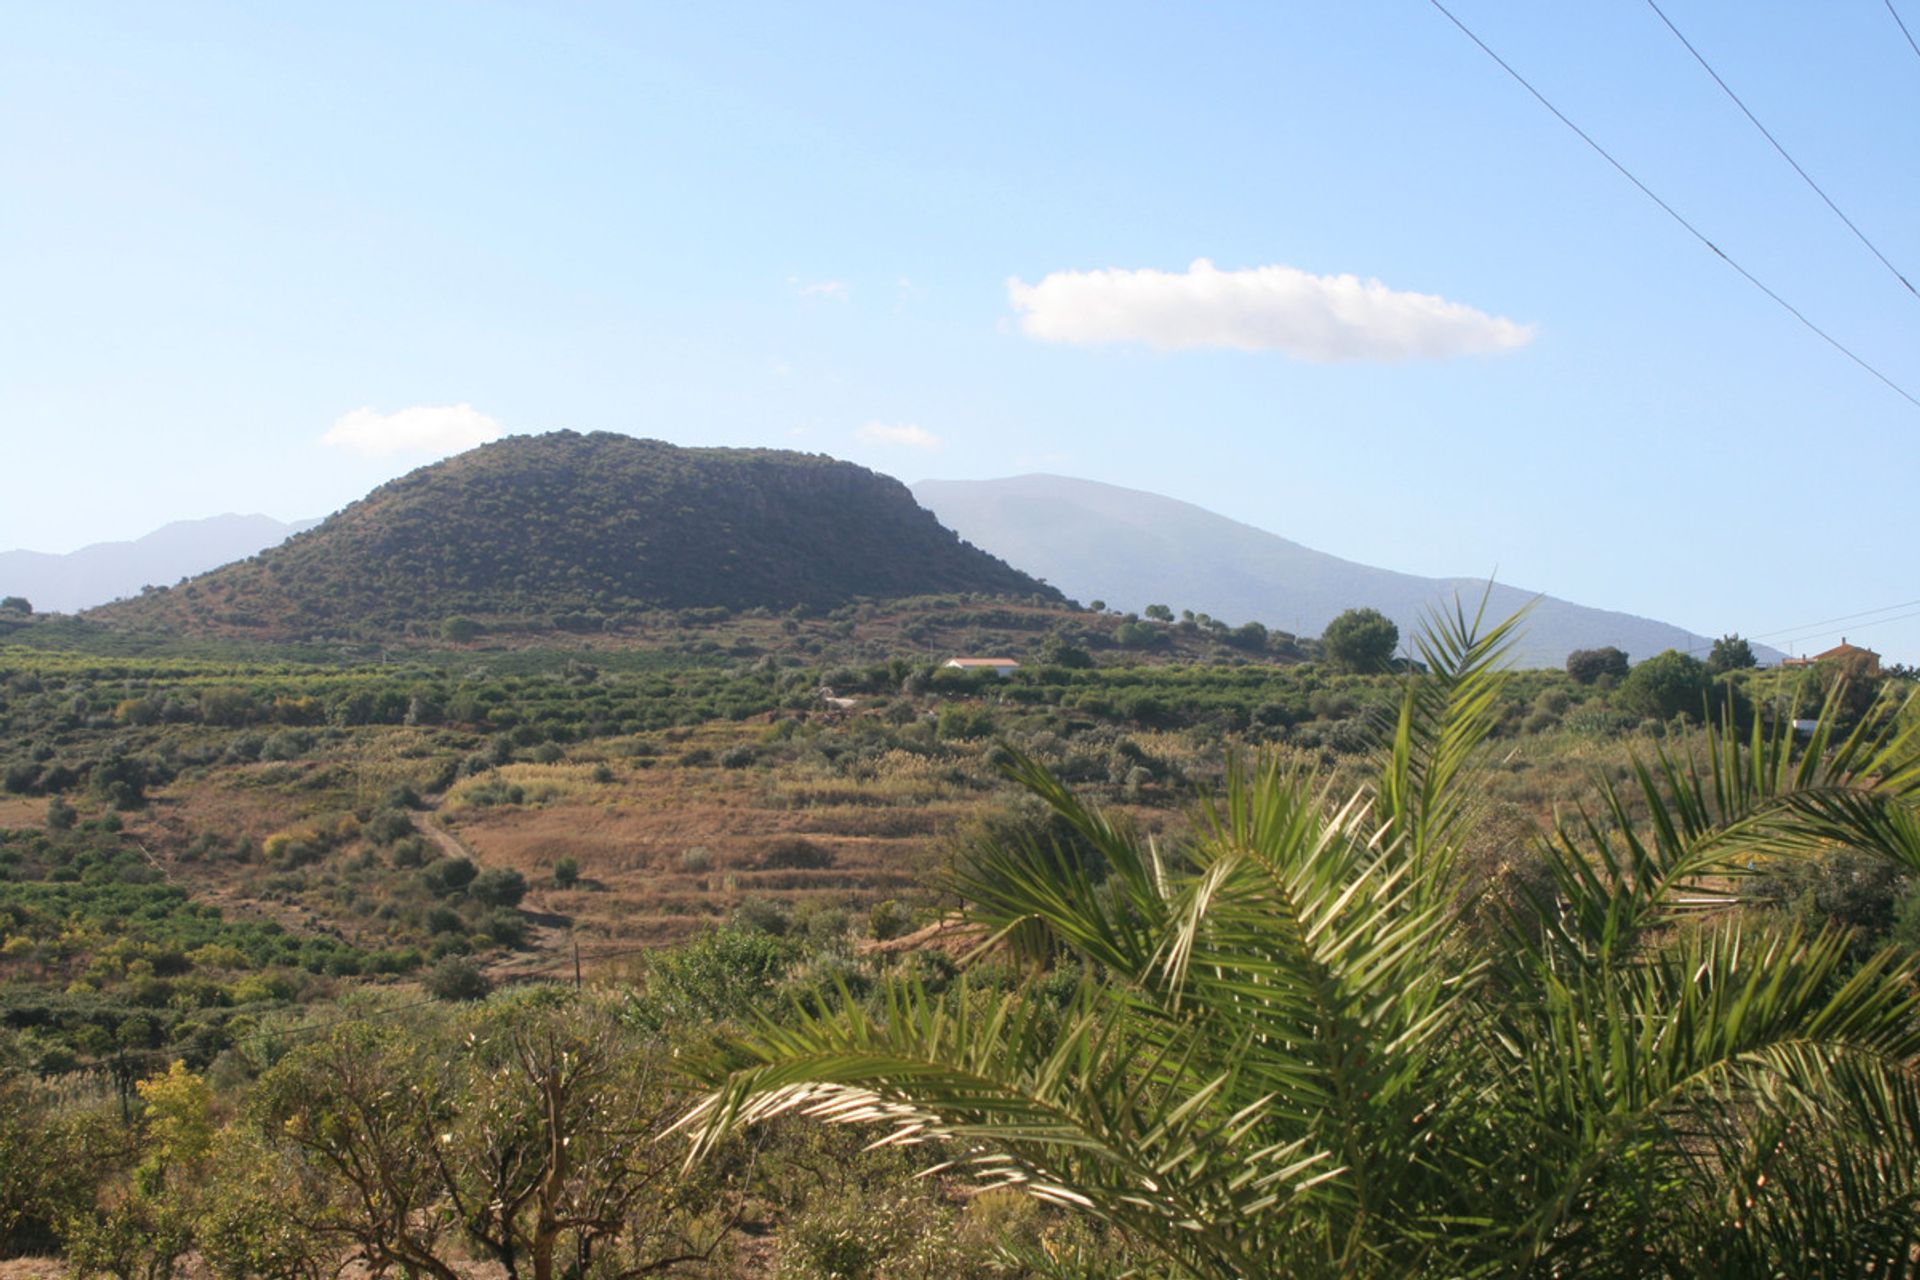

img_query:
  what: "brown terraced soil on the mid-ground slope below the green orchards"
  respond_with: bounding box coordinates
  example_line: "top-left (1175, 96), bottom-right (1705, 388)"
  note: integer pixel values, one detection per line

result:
top-left (71, 722), bottom-right (1036, 977)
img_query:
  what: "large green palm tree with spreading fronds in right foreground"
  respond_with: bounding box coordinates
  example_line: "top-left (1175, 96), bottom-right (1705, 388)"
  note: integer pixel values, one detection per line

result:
top-left (684, 608), bottom-right (1920, 1278)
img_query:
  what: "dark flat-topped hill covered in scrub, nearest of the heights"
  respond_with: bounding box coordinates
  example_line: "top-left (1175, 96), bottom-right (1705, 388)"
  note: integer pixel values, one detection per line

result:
top-left (92, 432), bottom-right (1058, 637)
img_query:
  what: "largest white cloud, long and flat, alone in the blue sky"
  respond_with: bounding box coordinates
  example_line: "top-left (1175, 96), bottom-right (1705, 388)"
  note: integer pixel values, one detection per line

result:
top-left (1006, 257), bottom-right (1534, 361)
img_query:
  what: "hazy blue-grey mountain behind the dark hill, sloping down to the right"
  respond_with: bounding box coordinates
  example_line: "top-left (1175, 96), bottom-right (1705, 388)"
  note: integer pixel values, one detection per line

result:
top-left (914, 476), bottom-right (1774, 666)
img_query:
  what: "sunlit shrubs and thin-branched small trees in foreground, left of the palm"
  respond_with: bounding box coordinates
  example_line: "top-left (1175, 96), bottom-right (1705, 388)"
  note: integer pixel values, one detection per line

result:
top-left (0, 955), bottom-right (1123, 1280)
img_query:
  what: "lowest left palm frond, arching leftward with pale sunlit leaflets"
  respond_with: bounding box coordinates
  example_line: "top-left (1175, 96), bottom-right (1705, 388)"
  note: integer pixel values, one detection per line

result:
top-left (682, 983), bottom-right (1336, 1265)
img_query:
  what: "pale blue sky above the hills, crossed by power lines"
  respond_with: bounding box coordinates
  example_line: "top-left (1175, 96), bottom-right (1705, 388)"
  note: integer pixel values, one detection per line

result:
top-left (0, 0), bottom-right (1920, 662)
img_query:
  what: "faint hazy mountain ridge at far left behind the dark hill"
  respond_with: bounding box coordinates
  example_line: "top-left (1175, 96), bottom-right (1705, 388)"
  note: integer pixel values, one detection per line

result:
top-left (0, 514), bottom-right (319, 614)
